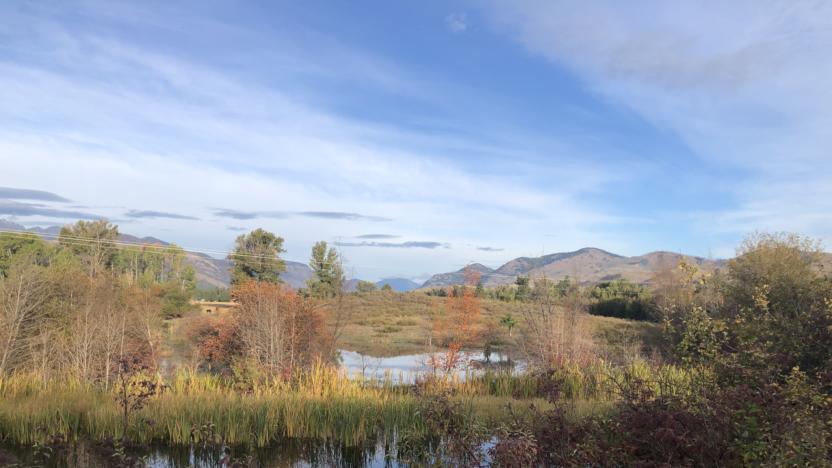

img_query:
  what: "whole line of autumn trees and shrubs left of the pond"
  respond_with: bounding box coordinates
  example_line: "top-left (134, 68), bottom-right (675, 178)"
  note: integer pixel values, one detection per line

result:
top-left (0, 220), bottom-right (346, 387)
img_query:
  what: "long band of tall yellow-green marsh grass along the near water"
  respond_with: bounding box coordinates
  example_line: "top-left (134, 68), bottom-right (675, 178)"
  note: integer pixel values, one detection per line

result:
top-left (0, 361), bottom-right (690, 447)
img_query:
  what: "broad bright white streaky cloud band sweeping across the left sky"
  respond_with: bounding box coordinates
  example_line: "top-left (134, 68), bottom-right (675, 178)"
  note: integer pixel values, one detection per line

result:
top-left (0, 3), bottom-right (644, 278)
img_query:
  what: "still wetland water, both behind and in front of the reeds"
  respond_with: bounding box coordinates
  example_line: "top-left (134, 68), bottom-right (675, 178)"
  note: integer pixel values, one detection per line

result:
top-left (0, 350), bottom-right (525, 468)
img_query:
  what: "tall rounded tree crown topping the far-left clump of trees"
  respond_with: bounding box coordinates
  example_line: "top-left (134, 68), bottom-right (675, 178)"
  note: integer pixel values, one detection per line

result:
top-left (58, 219), bottom-right (119, 277)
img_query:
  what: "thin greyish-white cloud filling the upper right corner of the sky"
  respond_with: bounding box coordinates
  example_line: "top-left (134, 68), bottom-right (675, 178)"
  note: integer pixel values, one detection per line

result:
top-left (482, 0), bottom-right (832, 242)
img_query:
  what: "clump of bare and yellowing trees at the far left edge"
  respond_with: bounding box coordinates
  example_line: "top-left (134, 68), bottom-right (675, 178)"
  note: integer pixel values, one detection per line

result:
top-left (0, 220), bottom-right (180, 387)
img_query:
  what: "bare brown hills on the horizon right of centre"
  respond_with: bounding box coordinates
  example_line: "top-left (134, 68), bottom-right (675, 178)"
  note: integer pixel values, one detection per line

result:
top-left (422, 247), bottom-right (724, 288)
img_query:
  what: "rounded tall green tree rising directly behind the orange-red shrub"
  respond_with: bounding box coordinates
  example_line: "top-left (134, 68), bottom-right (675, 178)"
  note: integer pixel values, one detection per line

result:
top-left (228, 228), bottom-right (286, 285)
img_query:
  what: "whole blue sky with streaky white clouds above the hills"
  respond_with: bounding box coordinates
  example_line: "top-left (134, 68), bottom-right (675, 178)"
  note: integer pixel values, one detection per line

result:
top-left (0, 0), bottom-right (832, 279)
